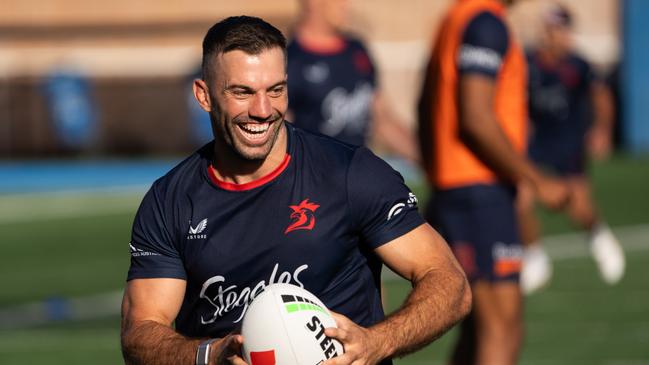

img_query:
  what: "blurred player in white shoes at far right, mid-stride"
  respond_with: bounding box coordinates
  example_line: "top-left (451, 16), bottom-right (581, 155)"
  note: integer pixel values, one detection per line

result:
top-left (518, 4), bottom-right (625, 293)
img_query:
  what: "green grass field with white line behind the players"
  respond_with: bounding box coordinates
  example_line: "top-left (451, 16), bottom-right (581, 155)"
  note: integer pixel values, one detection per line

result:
top-left (0, 152), bottom-right (649, 365)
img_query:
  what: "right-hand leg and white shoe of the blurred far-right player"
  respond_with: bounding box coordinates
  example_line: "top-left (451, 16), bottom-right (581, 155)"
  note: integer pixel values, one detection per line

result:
top-left (568, 175), bottom-right (625, 284)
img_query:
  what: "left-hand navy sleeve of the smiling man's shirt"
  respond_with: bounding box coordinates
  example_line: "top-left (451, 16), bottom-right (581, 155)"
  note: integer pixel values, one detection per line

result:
top-left (127, 183), bottom-right (187, 280)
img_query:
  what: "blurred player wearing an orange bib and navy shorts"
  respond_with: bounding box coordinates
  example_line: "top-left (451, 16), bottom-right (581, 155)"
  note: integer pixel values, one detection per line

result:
top-left (419, 0), bottom-right (567, 365)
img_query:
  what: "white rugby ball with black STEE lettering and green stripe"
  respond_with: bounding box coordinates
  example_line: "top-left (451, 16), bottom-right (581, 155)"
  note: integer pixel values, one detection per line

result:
top-left (241, 284), bottom-right (343, 365)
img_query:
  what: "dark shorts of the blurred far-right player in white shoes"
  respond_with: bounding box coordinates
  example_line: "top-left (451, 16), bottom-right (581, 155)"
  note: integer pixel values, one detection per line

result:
top-left (528, 137), bottom-right (586, 176)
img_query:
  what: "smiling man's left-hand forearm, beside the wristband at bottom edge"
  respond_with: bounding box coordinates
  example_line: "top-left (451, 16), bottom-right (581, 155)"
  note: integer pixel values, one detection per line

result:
top-left (122, 321), bottom-right (201, 365)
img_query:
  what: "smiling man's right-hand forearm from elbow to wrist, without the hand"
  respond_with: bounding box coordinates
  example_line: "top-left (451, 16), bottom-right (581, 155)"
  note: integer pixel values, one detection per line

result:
top-left (370, 268), bottom-right (471, 358)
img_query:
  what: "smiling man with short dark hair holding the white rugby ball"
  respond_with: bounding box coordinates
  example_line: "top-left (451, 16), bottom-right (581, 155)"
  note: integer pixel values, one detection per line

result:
top-left (122, 16), bottom-right (471, 365)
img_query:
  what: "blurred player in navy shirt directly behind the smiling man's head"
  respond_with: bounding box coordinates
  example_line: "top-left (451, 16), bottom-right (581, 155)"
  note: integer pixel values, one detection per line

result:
top-left (288, 0), bottom-right (418, 161)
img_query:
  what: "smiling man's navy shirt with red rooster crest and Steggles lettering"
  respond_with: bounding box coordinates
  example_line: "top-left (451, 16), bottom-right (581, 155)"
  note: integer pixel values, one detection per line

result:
top-left (128, 123), bottom-right (424, 337)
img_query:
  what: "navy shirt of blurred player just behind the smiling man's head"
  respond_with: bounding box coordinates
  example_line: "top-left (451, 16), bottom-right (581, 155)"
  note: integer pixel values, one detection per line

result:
top-left (287, 38), bottom-right (376, 146)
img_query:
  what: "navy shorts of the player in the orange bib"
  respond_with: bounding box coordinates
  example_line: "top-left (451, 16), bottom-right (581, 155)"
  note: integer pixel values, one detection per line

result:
top-left (426, 184), bottom-right (523, 282)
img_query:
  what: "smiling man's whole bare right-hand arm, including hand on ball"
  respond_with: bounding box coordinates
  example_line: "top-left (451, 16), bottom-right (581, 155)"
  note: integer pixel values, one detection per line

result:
top-left (325, 224), bottom-right (471, 365)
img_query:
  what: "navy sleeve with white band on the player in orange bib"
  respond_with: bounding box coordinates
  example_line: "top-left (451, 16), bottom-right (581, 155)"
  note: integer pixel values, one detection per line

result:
top-left (458, 12), bottom-right (509, 78)
